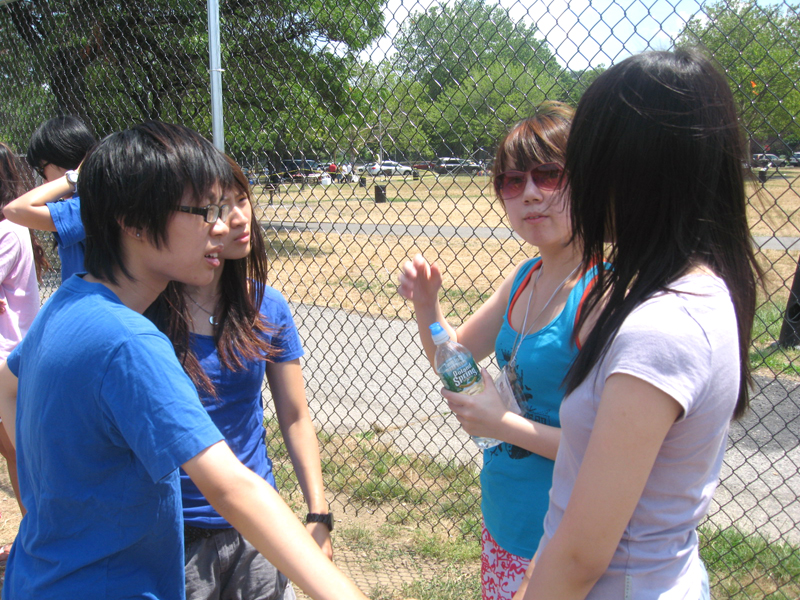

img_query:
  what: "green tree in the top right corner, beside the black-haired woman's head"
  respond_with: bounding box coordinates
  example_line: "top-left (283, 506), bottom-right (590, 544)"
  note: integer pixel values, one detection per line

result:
top-left (678, 0), bottom-right (800, 151)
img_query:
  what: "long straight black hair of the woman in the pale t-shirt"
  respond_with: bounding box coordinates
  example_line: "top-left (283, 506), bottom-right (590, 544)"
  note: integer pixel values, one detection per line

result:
top-left (565, 50), bottom-right (760, 418)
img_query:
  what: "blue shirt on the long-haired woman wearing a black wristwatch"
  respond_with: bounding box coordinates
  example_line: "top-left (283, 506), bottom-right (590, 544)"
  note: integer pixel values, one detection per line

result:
top-left (181, 286), bottom-right (303, 529)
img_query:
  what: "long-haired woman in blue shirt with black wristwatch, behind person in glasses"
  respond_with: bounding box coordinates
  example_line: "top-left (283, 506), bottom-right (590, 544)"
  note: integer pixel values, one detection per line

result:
top-left (145, 160), bottom-right (333, 600)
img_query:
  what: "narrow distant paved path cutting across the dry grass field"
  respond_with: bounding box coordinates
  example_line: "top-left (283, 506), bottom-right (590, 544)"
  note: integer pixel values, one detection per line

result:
top-left (261, 221), bottom-right (800, 251)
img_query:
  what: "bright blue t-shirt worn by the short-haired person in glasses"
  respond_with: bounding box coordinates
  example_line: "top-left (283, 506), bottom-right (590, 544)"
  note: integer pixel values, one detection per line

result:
top-left (3, 277), bottom-right (222, 600)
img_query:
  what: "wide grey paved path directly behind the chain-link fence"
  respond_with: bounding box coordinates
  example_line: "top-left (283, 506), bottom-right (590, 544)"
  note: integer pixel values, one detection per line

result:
top-left (268, 305), bottom-right (800, 543)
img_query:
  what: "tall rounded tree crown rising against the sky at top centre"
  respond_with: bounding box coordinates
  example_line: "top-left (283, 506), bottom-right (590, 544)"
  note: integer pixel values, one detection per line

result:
top-left (393, 0), bottom-right (561, 101)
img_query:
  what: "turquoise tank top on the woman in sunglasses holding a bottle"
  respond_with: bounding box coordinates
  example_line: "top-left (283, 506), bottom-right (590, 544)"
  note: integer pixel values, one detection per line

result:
top-left (481, 258), bottom-right (595, 559)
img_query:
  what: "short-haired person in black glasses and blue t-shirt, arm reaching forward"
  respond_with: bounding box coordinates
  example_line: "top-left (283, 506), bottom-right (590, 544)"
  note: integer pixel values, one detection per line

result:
top-left (0, 122), bottom-right (365, 600)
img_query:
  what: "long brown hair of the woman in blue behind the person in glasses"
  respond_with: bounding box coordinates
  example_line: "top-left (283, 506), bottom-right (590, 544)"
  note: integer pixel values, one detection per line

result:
top-left (145, 156), bottom-right (276, 396)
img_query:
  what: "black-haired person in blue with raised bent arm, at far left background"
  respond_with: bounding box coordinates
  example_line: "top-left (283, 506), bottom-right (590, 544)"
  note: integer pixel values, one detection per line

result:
top-left (3, 116), bottom-right (96, 282)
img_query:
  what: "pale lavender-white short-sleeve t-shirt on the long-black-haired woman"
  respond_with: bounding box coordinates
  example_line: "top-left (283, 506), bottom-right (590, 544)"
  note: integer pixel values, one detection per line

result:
top-left (538, 274), bottom-right (740, 600)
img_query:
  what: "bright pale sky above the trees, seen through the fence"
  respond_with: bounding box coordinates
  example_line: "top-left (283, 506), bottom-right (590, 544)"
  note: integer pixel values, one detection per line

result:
top-left (362, 0), bottom-right (700, 69)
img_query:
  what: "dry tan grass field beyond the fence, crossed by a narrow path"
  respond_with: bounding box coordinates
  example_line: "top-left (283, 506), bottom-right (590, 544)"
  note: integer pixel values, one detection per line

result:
top-left (255, 169), bottom-right (800, 319)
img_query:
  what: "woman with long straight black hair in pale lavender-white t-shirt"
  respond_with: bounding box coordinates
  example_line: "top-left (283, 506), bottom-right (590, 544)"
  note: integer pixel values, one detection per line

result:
top-left (517, 50), bottom-right (758, 600)
